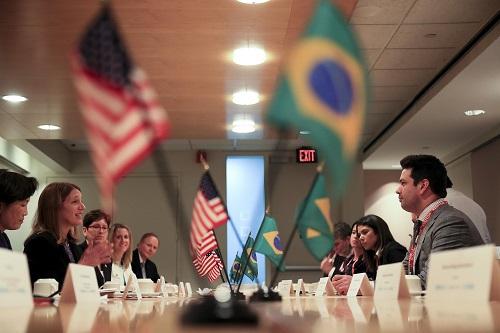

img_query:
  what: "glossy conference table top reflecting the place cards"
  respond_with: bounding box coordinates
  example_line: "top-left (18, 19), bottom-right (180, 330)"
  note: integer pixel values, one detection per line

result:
top-left (0, 296), bottom-right (500, 333)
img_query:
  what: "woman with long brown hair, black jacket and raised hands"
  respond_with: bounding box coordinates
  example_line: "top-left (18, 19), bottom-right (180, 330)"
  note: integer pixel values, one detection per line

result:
top-left (24, 183), bottom-right (111, 290)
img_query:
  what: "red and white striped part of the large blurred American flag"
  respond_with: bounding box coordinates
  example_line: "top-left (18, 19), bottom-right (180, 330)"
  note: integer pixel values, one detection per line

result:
top-left (73, 56), bottom-right (169, 211)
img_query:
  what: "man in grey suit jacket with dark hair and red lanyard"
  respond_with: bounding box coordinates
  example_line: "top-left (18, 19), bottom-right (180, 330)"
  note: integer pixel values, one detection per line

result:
top-left (396, 155), bottom-right (483, 289)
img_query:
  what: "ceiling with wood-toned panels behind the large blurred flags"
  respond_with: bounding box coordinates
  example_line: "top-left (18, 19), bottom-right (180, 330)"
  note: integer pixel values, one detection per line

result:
top-left (0, 0), bottom-right (500, 168)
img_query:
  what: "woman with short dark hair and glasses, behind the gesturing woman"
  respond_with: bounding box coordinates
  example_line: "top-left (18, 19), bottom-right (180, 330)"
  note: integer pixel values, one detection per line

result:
top-left (78, 209), bottom-right (111, 287)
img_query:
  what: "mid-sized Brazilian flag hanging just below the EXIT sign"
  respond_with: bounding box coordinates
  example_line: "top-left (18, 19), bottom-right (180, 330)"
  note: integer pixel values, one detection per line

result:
top-left (297, 173), bottom-right (333, 261)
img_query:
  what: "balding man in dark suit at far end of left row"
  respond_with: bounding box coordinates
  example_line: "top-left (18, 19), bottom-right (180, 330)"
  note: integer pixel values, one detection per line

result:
top-left (131, 232), bottom-right (160, 282)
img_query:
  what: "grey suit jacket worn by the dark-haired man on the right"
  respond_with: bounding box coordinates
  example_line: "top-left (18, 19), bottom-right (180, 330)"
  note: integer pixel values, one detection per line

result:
top-left (403, 205), bottom-right (483, 289)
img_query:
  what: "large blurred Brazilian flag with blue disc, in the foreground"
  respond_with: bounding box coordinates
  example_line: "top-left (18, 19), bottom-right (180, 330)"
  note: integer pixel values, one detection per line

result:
top-left (267, 0), bottom-right (368, 195)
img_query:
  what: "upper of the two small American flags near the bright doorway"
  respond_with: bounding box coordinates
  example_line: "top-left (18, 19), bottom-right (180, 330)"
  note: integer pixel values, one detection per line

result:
top-left (190, 171), bottom-right (228, 257)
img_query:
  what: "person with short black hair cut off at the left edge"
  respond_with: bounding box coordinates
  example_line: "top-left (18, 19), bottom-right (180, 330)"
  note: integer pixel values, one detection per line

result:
top-left (0, 169), bottom-right (38, 250)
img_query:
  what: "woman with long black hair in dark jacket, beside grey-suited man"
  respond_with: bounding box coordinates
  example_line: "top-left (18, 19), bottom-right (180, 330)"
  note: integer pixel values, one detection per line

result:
top-left (332, 215), bottom-right (406, 295)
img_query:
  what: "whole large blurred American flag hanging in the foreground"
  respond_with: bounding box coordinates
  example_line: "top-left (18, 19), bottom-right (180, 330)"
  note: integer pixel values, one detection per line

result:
top-left (72, 5), bottom-right (169, 212)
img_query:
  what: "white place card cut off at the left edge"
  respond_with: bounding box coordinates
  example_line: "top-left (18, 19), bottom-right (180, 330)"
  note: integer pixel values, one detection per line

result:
top-left (0, 249), bottom-right (33, 311)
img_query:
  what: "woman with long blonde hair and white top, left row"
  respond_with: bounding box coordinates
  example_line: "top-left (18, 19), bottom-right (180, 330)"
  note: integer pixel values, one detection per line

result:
top-left (109, 223), bottom-right (135, 285)
